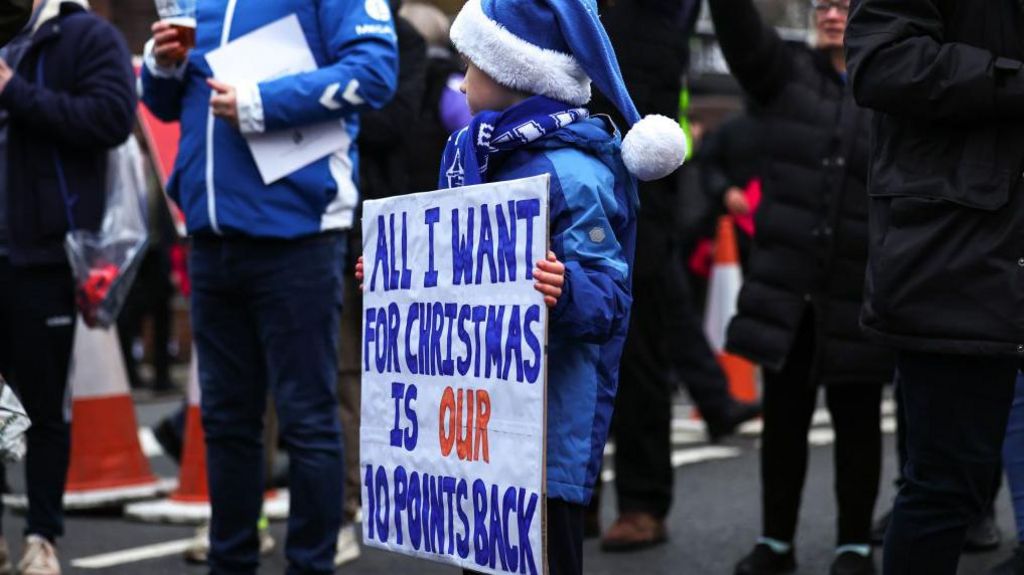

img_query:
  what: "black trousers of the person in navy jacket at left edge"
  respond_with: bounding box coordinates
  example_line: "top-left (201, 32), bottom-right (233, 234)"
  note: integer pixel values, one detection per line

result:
top-left (0, 258), bottom-right (77, 540)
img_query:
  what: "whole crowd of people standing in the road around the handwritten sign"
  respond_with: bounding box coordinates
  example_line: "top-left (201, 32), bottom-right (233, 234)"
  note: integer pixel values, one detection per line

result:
top-left (0, 0), bottom-right (1024, 575)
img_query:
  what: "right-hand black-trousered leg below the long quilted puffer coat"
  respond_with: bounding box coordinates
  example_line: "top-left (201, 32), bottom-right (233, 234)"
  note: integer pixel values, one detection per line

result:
top-left (825, 383), bottom-right (882, 544)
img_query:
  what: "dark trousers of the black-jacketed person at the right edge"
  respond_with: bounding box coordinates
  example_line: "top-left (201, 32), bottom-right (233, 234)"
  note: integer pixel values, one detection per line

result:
top-left (884, 352), bottom-right (1022, 575)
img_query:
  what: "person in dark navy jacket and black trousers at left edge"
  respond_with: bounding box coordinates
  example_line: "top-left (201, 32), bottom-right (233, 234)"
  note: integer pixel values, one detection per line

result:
top-left (0, 0), bottom-right (135, 575)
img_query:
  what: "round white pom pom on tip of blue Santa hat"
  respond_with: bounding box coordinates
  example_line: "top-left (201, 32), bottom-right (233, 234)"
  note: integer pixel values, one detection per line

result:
top-left (623, 114), bottom-right (686, 182)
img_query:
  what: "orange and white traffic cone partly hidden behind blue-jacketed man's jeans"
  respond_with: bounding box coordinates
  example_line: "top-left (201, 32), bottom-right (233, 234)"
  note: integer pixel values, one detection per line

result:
top-left (125, 349), bottom-right (289, 525)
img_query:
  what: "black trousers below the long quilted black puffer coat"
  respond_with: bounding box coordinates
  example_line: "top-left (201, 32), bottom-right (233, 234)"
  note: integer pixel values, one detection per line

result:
top-left (761, 313), bottom-right (880, 540)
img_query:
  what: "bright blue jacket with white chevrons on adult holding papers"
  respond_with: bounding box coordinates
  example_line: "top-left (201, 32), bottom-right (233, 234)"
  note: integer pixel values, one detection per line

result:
top-left (142, 0), bottom-right (398, 238)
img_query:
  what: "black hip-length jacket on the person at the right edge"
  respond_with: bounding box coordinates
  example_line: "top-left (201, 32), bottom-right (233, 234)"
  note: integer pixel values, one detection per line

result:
top-left (847, 0), bottom-right (1024, 357)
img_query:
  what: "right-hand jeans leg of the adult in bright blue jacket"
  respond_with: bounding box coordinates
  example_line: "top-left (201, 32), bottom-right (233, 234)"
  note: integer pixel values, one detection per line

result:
top-left (250, 235), bottom-right (345, 574)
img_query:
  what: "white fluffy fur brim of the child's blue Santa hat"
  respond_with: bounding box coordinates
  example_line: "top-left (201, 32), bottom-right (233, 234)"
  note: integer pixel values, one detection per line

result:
top-left (451, 0), bottom-right (590, 105)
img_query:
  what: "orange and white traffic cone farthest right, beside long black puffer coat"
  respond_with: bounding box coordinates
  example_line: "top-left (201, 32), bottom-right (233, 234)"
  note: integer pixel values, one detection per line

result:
top-left (705, 216), bottom-right (758, 401)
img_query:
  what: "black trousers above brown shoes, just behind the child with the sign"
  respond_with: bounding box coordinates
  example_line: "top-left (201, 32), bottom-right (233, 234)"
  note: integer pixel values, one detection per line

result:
top-left (611, 210), bottom-right (733, 518)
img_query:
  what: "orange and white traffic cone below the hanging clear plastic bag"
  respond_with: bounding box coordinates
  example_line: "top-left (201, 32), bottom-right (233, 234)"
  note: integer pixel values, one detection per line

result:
top-left (4, 319), bottom-right (174, 510)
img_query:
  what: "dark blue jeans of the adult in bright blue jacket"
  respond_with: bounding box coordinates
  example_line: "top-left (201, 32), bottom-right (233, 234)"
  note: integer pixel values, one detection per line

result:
top-left (191, 234), bottom-right (345, 575)
